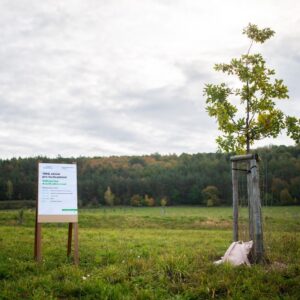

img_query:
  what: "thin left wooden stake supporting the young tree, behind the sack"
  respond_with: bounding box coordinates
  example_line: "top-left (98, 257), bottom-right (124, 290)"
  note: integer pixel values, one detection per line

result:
top-left (231, 161), bottom-right (239, 242)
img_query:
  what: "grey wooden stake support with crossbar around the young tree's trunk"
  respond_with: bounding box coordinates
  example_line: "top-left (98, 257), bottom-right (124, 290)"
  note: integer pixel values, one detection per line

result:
top-left (230, 154), bottom-right (264, 263)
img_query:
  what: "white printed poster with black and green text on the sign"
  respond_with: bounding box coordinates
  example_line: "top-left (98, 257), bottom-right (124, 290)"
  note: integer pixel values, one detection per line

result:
top-left (38, 163), bottom-right (78, 220)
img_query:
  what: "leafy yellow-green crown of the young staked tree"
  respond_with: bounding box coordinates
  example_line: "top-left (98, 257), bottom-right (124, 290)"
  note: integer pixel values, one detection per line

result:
top-left (204, 24), bottom-right (300, 153)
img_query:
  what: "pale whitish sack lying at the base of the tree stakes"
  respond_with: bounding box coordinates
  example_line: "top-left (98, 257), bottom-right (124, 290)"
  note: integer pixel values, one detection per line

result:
top-left (214, 241), bottom-right (253, 266)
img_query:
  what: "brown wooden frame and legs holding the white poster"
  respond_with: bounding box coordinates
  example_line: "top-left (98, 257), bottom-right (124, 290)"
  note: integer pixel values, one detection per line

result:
top-left (34, 162), bottom-right (79, 265)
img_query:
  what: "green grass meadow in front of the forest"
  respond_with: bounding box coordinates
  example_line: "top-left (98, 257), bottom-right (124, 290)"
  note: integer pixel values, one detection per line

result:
top-left (0, 207), bottom-right (300, 299)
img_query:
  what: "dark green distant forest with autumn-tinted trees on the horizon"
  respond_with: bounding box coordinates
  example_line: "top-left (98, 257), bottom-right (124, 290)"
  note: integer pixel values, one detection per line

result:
top-left (0, 145), bottom-right (300, 207)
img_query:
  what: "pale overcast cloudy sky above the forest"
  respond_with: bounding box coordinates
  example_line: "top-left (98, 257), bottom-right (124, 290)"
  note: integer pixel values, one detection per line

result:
top-left (0, 0), bottom-right (300, 158)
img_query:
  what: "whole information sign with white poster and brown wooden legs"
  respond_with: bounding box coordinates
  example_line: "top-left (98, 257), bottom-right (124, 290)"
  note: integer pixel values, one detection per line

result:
top-left (34, 163), bottom-right (79, 265)
